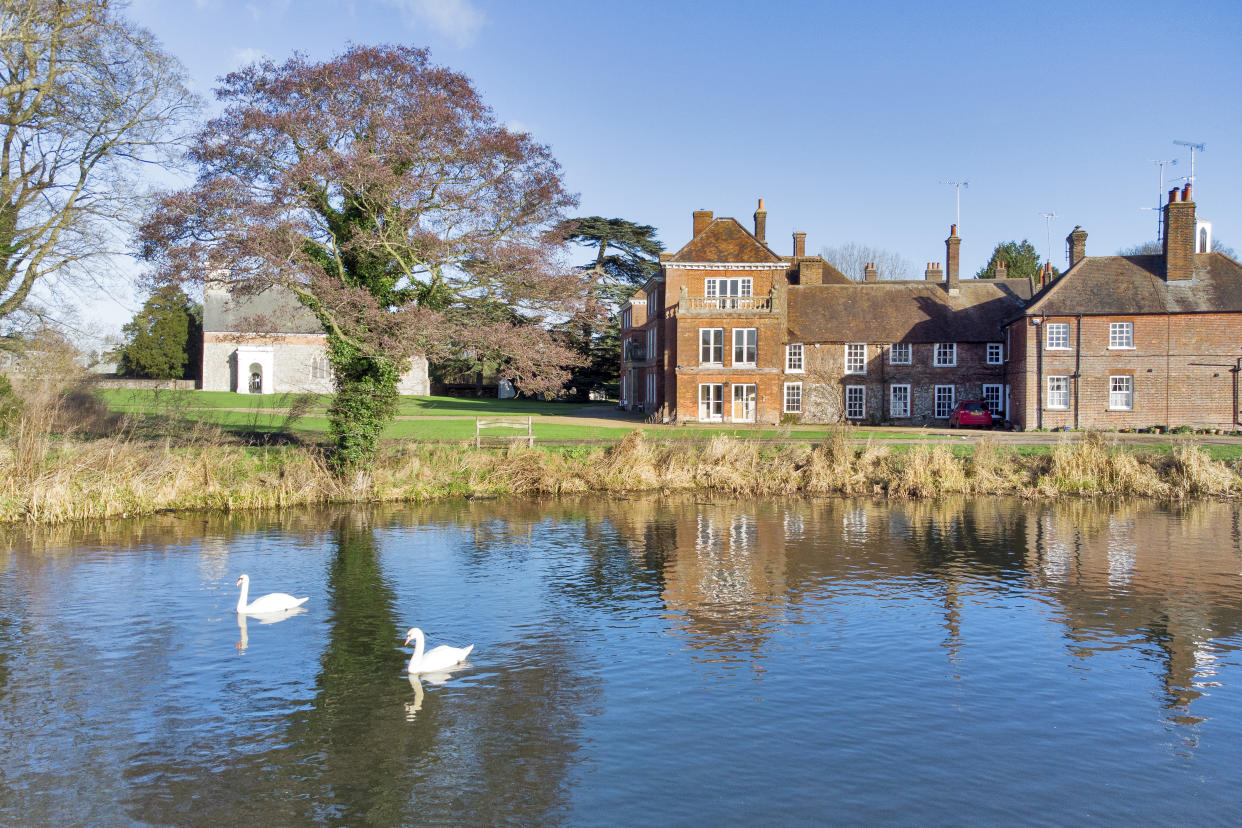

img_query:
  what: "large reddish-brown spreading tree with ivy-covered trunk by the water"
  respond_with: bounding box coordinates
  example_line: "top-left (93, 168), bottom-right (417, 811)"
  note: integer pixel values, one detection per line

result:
top-left (143, 46), bottom-right (584, 469)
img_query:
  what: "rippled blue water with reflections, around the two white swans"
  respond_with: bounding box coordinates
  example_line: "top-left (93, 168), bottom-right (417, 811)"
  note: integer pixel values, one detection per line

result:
top-left (0, 499), bottom-right (1242, 826)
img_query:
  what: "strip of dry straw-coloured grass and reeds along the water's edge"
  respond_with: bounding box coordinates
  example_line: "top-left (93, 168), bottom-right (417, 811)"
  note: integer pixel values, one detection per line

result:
top-left (0, 430), bottom-right (1242, 523)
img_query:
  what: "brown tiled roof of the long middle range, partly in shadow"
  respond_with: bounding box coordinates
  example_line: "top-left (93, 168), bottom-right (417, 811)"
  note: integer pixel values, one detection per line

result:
top-left (789, 279), bottom-right (1031, 343)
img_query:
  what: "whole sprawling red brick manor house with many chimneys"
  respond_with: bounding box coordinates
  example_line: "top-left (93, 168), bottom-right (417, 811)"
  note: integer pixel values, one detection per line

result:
top-left (621, 185), bottom-right (1242, 428)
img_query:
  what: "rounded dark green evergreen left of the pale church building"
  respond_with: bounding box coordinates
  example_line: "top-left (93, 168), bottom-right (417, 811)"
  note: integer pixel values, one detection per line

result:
top-left (120, 286), bottom-right (202, 380)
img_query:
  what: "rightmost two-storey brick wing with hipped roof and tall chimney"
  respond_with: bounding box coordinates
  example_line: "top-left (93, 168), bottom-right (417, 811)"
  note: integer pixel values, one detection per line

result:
top-left (1005, 185), bottom-right (1242, 428)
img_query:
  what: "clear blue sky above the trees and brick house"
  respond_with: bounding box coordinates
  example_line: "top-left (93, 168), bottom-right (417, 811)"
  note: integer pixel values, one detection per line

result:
top-left (80, 0), bottom-right (1242, 337)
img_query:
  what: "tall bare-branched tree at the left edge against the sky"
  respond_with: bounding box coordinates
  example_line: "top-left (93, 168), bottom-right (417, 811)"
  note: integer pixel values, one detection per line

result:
top-left (0, 0), bottom-right (196, 320)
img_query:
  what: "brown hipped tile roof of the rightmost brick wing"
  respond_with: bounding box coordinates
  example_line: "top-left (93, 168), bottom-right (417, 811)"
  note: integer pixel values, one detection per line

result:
top-left (1023, 253), bottom-right (1242, 315)
